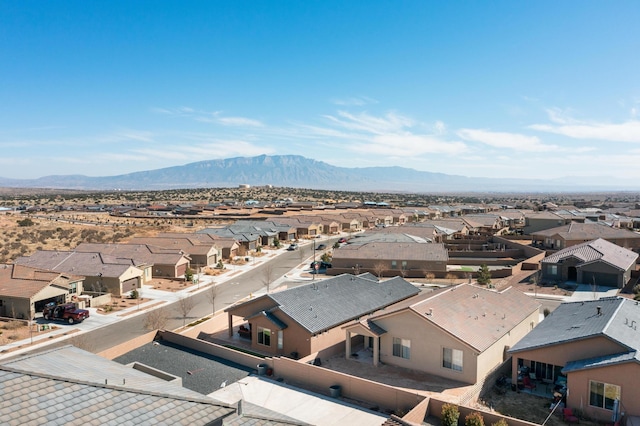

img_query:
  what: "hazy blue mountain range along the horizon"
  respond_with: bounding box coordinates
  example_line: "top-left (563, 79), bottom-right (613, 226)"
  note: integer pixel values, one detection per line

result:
top-left (0, 155), bottom-right (638, 193)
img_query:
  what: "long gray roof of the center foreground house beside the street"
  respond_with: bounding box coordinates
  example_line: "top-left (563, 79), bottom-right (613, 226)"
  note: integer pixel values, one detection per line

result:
top-left (268, 274), bottom-right (420, 334)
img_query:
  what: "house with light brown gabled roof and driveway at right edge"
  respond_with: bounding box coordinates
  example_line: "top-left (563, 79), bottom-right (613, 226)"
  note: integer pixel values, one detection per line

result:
top-left (541, 238), bottom-right (638, 288)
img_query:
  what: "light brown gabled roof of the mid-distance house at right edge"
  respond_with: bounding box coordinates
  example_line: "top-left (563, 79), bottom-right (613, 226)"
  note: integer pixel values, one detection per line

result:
top-left (542, 238), bottom-right (638, 271)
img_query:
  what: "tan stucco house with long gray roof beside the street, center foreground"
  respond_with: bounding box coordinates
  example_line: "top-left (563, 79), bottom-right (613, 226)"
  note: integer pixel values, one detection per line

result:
top-left (226, 274), bottom-right (420, 358)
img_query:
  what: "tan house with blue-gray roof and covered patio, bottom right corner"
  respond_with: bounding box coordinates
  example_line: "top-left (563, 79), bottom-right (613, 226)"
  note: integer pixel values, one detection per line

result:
top-left (509, 297), bottom-right (640, 421)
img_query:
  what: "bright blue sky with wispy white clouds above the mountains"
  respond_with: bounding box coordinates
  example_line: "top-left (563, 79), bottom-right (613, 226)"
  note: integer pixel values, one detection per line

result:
top-left (0, 0), bottom-right (640, 180)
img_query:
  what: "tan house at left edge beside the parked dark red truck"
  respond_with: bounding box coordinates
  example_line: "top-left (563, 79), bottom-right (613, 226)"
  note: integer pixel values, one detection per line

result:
top-left (0, 264), bottom-right (84, 319)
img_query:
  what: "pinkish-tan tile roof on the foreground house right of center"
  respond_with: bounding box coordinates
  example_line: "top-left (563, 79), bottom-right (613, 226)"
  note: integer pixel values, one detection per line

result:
top-left (404, 284), bottom-right (540, 352)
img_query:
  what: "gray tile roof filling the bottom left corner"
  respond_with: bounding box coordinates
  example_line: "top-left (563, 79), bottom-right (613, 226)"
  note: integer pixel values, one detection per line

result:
top-left (0, 348), bottom-right (235, 426)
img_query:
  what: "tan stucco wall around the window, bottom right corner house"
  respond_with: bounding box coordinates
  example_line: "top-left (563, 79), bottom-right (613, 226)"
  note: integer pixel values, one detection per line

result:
top-left (567, 362), bottom-right (640, 421)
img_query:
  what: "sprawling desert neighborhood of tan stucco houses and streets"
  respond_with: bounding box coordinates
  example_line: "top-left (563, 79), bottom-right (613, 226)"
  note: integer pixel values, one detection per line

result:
top-left (0, 194), bottom-right (640, 425)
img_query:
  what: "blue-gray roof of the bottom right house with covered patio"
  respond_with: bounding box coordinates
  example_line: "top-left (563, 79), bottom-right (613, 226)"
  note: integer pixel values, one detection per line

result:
top-left (511, 297), bottom-right (640, 352)
